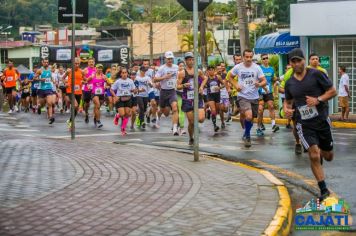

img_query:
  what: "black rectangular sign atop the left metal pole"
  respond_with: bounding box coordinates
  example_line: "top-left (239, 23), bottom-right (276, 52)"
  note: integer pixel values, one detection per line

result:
top-left (58, 0), bottom-right (89, 24)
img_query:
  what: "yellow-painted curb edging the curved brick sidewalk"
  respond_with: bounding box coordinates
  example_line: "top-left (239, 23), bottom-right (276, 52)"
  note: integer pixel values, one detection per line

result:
top-left (207, 156), bottom-right (293, 236)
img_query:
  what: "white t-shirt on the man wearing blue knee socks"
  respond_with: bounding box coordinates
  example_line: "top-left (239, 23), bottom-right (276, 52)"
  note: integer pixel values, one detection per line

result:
top-left (231, 63), bottom-right (264, 100)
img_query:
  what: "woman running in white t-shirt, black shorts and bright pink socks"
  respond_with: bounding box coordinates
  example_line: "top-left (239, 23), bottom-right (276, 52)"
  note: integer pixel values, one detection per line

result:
top-left (111, 68), bottom-right (137, 136)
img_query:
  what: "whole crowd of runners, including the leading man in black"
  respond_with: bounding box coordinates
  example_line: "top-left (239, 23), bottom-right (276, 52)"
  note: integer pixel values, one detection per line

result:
top-left (1, 49), bottom-right (336, 201)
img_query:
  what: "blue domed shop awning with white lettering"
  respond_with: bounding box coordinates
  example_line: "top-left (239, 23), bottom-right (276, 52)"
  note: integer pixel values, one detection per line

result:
top-left (255, 32), bottom-right (300, 54)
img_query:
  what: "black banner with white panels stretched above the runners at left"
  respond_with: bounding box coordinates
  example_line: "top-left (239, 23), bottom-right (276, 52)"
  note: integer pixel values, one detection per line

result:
top-left (40, 45), bottom-right (130, 66)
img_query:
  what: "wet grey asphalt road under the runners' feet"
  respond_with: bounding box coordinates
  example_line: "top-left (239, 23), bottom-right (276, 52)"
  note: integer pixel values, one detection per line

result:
top-left (0, 111), bottom-right (356, 235)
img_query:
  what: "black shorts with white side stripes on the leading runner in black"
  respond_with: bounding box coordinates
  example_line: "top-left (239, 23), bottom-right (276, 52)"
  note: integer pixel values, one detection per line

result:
top-left (296, 118), bottom-right (333, 151)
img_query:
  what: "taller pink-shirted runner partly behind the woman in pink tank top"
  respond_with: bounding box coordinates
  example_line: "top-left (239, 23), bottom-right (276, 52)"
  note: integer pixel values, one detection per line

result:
top-left (82, 58), bottom-right (96, 124)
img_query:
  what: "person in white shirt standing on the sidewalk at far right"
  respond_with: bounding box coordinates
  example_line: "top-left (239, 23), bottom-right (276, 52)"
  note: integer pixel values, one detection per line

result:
top-left (339, 66), bottom-right (350, 121)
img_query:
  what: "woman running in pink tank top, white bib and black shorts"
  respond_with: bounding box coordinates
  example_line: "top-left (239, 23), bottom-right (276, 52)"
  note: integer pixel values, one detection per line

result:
top-left (86, 64), bottom-right (107, 129)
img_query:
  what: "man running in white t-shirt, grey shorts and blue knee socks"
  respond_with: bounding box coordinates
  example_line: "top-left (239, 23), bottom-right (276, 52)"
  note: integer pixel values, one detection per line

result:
top-left (231, 49), bottom-right (266, 148)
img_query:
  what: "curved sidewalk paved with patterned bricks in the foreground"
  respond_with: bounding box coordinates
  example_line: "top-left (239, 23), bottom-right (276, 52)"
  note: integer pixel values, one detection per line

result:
top-left (0, 134), bottom-right (279, 236)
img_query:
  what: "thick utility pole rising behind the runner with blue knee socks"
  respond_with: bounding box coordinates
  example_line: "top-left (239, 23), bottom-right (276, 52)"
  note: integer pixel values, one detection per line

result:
top-left (236, 0), bottom-right (250, 52)
